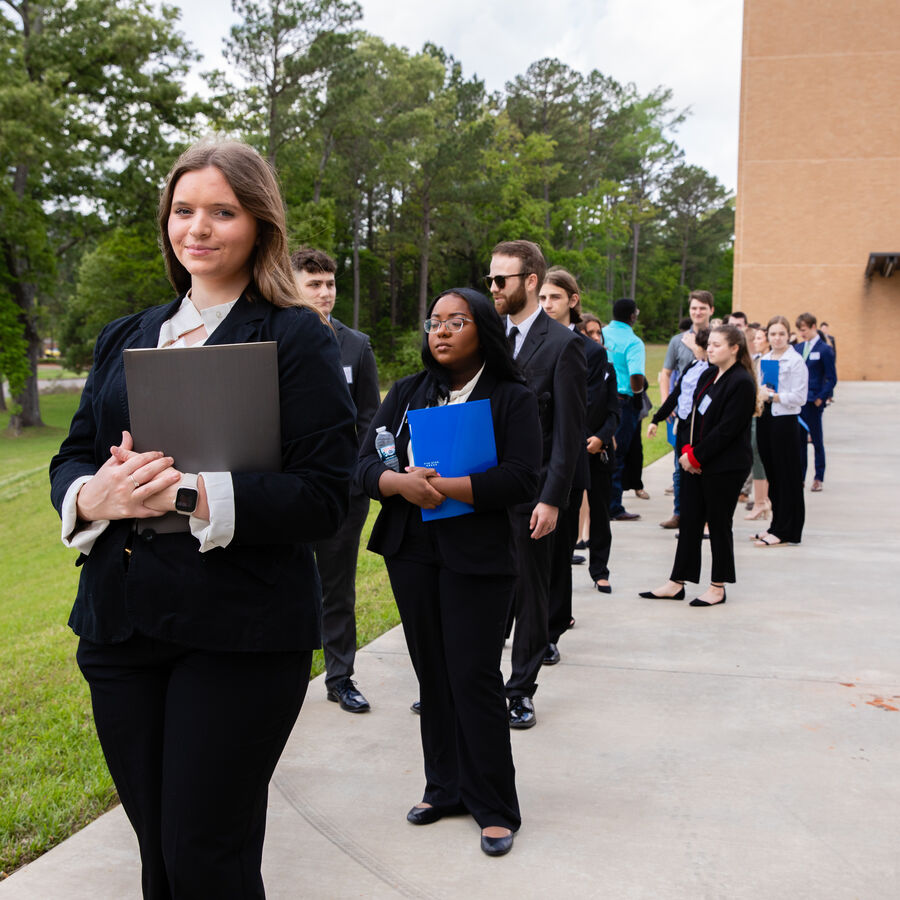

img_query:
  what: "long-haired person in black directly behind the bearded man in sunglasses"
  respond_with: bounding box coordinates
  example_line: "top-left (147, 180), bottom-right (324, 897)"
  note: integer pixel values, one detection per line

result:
top-left (539, 266), bottom-right (619, 620)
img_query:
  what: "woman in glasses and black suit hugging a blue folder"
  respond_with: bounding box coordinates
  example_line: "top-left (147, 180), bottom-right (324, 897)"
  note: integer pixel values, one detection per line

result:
top-left (357, 288), bottom-right (541, 856)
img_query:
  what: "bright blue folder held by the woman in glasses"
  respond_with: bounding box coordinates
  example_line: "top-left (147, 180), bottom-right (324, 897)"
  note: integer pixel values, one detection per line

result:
top-left (407, 400), bottom-right (497, 522)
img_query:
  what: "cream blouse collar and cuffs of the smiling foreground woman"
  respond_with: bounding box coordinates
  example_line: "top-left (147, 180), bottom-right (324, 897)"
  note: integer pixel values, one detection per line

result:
top-left (62, 291), bottom-right (243, 556)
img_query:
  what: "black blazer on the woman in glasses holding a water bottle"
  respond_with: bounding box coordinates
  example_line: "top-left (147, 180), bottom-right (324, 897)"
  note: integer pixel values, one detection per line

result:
top-left (357, 369), bottom-right (541, 575)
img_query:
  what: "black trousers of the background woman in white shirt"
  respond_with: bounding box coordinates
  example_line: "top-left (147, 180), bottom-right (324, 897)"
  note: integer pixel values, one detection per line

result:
top-left (756, 404), bottom-right (806, 544)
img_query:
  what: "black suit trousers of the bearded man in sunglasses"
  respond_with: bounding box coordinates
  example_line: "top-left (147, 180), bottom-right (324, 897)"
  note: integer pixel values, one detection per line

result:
top-left (506, 512), bottom-right (554, 697)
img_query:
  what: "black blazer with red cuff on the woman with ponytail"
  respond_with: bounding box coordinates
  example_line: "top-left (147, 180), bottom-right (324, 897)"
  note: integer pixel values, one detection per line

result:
top-left (676, 363), bottom-right (756, 474)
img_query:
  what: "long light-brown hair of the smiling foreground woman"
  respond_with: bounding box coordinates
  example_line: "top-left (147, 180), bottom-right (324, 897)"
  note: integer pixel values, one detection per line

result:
top-left (158, 139), bottom-right (321, 315)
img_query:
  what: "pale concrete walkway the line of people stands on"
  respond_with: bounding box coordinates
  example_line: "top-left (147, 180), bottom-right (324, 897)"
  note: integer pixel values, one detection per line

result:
top-left (0, 383), bottom-right (900, 900)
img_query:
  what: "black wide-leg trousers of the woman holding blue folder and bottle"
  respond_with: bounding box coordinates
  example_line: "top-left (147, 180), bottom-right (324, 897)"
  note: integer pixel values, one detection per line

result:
top-left (385, 557), bottom-right (520, 831)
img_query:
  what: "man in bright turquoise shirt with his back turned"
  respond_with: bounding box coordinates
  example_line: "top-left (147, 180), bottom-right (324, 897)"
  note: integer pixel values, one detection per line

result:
top-left (603, 297), bottom-right (646, 522)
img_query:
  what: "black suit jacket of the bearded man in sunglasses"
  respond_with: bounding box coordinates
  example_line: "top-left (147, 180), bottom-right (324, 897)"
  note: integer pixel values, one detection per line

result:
top-left (504, 310), bottom-right (587, 512)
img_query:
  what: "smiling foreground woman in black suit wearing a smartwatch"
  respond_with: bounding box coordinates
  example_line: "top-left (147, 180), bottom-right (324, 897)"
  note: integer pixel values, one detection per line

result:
top-left (50, 141), bottom-right (355, 900)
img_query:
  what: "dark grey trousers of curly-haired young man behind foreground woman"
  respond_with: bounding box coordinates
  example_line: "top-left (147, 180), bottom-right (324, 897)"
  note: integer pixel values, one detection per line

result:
top-left (313, 494), bottom-right (369, 688)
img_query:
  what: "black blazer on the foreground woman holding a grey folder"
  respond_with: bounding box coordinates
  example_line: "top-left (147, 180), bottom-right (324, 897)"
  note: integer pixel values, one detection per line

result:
top-left (50, 289), bottom-right (356, 650)
